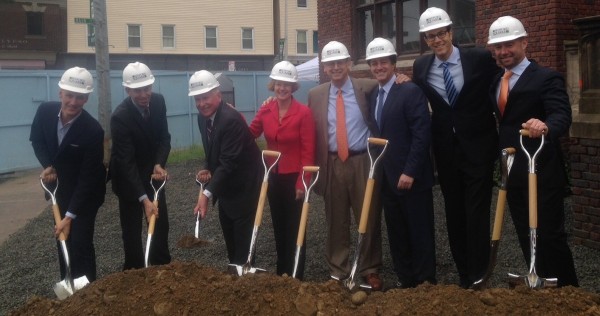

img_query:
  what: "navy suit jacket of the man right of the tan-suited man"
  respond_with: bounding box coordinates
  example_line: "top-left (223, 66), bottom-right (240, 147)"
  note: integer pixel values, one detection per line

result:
top-left (371, 82), bottom-right (433, 195)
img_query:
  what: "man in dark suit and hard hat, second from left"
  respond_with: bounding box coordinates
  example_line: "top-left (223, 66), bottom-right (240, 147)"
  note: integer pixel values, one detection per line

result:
top-left (110, 62), bottom-right (171, 270)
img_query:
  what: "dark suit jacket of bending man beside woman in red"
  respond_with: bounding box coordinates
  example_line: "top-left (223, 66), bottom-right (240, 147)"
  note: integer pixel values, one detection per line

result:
top-left (198, 102), bottom-right (264, 218)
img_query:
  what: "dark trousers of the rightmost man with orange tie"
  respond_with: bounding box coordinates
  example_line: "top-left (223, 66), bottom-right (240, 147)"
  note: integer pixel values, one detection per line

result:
top-left (507, 187), bottom-right (579, 286)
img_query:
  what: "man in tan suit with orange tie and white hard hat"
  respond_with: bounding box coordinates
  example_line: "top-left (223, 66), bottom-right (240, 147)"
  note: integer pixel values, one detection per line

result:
top-left (308, 41), bottom-right (382, 290)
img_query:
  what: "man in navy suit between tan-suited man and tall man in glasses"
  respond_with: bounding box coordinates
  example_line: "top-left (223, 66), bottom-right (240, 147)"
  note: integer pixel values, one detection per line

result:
top-left (366, 37), bottom-right (437, 288)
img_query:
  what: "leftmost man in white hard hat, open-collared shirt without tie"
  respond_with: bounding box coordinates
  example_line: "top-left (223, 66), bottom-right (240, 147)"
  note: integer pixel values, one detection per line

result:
top-left (29, 67), bottom-right (106, 281)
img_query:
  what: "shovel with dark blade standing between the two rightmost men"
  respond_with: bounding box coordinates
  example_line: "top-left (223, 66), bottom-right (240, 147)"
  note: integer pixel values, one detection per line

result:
top-left (472, 147), bottom-right (516, 290)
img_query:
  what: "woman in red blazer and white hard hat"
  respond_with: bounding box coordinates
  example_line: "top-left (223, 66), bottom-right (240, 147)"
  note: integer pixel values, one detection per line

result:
top-left (250, 61), bottom-right (315, 279)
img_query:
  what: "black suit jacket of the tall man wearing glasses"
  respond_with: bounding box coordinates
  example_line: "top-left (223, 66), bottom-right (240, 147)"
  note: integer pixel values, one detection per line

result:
top-left (413, 48), bottom-right (500, 165)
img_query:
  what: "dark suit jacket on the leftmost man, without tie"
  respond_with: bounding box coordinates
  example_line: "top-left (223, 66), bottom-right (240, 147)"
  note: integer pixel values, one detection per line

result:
top-left (29, 102), bottom-right (106, 215)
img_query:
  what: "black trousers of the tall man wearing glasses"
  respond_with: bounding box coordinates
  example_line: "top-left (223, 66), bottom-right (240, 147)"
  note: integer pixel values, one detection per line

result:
top-left (436, 148), bottom-right (494, 287)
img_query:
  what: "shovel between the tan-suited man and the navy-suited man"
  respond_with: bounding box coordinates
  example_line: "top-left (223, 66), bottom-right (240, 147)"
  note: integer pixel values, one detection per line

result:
top-left (343, 137), bottom-right (388, 290)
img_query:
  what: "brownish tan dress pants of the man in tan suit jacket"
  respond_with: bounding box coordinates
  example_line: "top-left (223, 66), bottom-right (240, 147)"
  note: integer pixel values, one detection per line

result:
top-left (324, 153), bottom-right (382, 279)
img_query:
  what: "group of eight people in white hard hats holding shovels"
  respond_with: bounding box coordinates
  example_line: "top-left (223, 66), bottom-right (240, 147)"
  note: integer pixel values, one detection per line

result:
top-left (30, 7), bottom-right (578, 290)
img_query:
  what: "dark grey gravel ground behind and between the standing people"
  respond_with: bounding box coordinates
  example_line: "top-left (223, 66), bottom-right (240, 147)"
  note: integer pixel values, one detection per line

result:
top-left (0, 160), bottom-right (600, 315)
